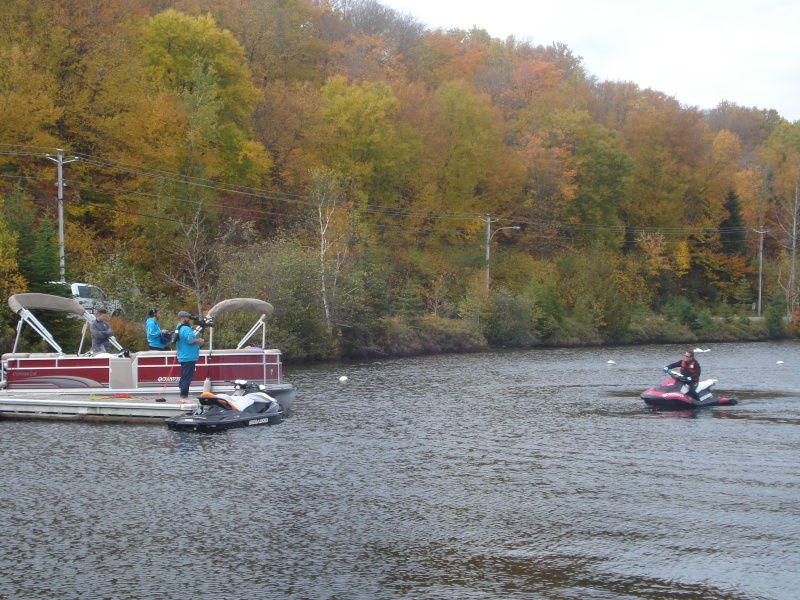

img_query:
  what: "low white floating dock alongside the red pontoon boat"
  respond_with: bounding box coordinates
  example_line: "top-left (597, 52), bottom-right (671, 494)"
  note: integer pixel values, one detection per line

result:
top-left (0, 393), bottom-right (192, 424)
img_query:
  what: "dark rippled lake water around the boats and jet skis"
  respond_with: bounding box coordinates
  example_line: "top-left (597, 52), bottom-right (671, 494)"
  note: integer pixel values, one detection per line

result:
top-left (0, 343), bottom-right (800, 599)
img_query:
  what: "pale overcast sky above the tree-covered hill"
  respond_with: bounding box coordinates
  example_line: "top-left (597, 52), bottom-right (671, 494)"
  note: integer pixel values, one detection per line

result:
top-left (379, 0), bottom-right (800, 121)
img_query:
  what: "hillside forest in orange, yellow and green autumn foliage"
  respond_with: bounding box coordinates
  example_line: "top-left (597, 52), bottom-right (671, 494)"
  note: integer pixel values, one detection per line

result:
top-left (0, 0), bottom-right (800, 361)
